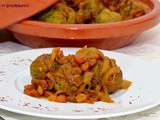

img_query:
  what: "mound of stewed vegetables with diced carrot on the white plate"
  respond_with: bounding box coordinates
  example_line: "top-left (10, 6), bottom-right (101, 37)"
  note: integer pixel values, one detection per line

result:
top-left (24, 47), bottom-right (131, 103)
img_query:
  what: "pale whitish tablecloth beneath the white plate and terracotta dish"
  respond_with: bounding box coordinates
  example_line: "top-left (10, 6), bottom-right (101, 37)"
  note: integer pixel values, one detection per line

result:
top-left (0, 25), bottom-right (160, 120)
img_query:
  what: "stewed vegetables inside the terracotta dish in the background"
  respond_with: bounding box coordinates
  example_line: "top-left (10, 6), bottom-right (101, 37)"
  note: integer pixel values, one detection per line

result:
top-left (38, 0), bottom-right (151, 24)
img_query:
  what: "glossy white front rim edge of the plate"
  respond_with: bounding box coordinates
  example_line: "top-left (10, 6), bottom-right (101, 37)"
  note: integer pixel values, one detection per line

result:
top-left (0, 101), bottom-right (160, 120)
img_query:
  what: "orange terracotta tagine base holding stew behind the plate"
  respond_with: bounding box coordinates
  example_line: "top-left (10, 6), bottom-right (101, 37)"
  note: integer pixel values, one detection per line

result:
top-left (8, 0), bottom-right (160, 49)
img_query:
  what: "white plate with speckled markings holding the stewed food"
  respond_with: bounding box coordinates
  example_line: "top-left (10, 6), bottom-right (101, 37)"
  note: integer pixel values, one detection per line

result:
top-left (0, 48), bottom-right (160, 119)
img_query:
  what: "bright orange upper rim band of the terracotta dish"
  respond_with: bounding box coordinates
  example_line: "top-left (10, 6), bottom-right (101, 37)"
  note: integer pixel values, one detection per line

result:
top-left (8, 0), bottom-right (160, 39)
